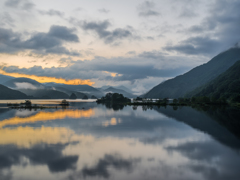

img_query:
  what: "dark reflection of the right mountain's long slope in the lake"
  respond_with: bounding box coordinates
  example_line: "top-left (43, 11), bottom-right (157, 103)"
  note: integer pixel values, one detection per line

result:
top-left (154, 107), bottom-right (240, 149)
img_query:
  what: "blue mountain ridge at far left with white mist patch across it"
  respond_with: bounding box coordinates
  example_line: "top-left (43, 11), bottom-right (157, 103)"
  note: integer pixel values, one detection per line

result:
top-left (3, 78), bottom-right (45, 89)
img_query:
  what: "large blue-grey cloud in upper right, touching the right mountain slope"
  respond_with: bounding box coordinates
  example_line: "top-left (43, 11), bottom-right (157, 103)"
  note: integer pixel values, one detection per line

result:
top-left (164, 0), bottom-right (240, 56)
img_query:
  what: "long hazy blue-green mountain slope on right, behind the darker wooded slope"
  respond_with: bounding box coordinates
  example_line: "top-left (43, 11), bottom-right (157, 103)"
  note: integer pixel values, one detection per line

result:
top-left (144, 47), bottom-right (240, 98)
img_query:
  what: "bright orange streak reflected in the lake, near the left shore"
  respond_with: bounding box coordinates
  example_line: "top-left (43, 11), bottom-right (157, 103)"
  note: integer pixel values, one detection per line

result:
top-left (0, 109), bottom-right (95, 129)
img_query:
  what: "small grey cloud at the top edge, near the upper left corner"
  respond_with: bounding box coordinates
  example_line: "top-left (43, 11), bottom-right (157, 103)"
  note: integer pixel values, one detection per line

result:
top-left (5, 0), bottom-right (35, 10)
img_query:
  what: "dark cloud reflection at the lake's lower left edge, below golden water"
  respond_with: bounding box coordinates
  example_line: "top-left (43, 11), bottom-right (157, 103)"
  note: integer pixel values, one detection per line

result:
top-left (0, 144), bottom-right (78, 172)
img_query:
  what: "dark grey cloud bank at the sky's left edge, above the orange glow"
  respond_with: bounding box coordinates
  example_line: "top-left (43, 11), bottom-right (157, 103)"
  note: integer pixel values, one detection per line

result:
top-left (0, 26), bottom-right (80, 56)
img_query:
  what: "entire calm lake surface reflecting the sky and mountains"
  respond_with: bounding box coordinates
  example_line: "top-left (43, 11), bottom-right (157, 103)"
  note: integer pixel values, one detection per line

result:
top-left (0, 102), bottom-right (240, 180)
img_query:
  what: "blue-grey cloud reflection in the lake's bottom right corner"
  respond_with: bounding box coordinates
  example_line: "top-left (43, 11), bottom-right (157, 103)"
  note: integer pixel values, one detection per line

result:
top-left (166, 141), bottom-right (240, 180)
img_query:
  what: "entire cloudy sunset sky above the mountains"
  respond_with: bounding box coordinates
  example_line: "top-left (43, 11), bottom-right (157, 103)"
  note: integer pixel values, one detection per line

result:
top-left (0, 0), bottom-right (240, 93)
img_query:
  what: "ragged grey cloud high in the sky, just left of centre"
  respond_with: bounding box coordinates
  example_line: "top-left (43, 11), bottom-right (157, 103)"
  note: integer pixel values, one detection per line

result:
top-left (81, 20), bottom-right (133, 44)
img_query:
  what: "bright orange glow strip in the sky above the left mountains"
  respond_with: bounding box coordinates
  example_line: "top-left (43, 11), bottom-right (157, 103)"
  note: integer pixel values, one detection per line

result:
top-left (0, 69), bottom-right (95, 86)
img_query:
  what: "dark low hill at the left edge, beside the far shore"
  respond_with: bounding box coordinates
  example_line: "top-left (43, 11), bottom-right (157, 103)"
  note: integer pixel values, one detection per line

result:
top-left (0, 84), bottom-right (28, 99)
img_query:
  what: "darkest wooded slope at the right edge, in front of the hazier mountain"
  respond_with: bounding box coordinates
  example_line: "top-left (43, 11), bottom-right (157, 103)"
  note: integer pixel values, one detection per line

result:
top-left (187, 57), bottom-right (240, 102)
